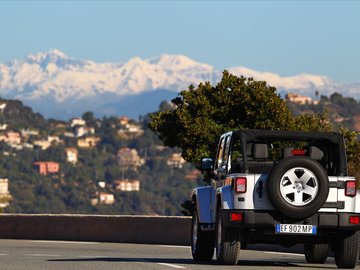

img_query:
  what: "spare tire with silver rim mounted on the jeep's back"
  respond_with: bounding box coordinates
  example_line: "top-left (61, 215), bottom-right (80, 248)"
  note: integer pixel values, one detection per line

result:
top-left (267, 156), bottom-right (329, 219)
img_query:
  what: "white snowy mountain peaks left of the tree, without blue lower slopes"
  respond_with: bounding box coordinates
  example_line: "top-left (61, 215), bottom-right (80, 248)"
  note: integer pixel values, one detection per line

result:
top-left (0, 50), bottom-right (214, 103)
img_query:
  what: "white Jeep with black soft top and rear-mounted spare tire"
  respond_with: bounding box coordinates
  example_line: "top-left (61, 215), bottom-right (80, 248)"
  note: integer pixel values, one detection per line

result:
top-left (191, 130), bottom-right (360, 268)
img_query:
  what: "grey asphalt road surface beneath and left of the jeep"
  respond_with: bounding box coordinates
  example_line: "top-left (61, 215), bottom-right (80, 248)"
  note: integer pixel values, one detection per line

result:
top-left (0, 240), bottom-right (360, 270)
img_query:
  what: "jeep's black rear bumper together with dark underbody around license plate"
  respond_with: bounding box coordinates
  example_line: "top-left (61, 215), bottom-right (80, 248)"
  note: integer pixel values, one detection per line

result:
top-left (221, 210), bottom-right (360, 248)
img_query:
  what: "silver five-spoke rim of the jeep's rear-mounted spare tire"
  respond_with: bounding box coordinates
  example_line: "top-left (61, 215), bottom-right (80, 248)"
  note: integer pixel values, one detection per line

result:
top-left (280, 167), bottom-right (319, 206)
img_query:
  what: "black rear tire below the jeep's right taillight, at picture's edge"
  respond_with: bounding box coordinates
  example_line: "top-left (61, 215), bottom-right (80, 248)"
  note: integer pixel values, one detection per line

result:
top-left (335, 232), bottom-right (360, 268)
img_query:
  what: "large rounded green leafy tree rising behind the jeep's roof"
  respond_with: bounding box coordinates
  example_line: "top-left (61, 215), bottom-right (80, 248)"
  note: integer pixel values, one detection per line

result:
top-left (149, 71), bottom-right (295, 163)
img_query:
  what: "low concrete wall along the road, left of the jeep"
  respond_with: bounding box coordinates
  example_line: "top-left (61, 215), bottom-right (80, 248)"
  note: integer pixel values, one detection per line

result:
top-left (0, 214), bottom-right (191, 245)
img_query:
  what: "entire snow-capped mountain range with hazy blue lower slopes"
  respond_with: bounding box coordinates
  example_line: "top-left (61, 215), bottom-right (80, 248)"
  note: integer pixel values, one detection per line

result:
top-left (0, 50), bottom-right (360, 119)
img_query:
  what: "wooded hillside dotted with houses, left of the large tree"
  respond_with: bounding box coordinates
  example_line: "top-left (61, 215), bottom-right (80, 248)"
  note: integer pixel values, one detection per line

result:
top-left (0, 99), bottom-right (200, 215)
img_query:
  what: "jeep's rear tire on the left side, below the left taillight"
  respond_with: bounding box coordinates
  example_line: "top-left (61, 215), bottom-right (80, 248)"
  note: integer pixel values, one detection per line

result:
top-left (215, 210), bottom-right (241, 265)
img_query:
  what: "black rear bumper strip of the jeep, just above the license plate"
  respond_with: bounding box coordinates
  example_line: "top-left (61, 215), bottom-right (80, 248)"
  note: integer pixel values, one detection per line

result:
top-left (221, 210), bottom-right (360, 231)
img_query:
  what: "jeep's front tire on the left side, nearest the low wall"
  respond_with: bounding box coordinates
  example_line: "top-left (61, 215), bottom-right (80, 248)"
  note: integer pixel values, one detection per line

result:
top-left (191, 210), bottom-right (215, 261)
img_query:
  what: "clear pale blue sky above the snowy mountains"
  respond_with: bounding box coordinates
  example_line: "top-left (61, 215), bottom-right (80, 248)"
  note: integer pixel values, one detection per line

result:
top-left (0, 0), bottom-right (360, 82)
